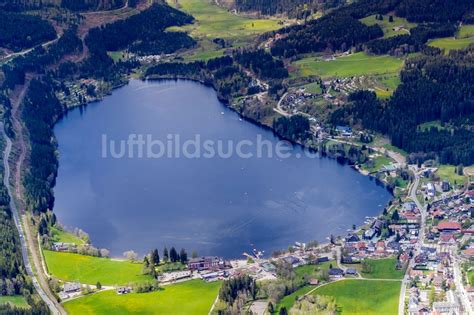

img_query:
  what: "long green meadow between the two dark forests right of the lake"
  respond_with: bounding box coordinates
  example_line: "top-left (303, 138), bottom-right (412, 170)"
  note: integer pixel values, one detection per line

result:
top-left (294, 52), bottom-right (403, 78)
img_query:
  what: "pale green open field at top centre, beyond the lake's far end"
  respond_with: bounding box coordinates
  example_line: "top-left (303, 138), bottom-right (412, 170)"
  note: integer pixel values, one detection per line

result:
top-left (168, 0), bottom-right (284, 60)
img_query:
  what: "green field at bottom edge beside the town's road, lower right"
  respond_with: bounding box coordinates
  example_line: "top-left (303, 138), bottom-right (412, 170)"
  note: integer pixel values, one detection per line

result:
top-left (311, 280), bottom-right (401, 315)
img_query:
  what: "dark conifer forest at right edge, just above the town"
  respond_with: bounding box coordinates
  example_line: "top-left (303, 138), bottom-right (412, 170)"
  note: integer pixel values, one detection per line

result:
top-left (332, 47), bottom-right (474, 165)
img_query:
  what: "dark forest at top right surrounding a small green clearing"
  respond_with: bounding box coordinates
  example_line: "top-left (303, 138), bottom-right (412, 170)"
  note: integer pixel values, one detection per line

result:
top-left (272, 0), bottom-right (474, 57)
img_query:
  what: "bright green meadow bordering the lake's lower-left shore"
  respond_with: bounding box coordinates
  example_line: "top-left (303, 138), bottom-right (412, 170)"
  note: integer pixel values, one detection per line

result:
top-left (44, 250), bottom-right (151, 285)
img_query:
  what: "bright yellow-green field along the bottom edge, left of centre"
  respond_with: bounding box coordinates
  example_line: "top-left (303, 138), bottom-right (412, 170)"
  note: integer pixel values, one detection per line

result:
top-left (64, 280), bottom-right (221, 315)
